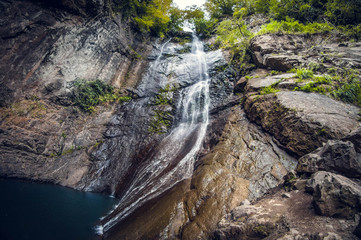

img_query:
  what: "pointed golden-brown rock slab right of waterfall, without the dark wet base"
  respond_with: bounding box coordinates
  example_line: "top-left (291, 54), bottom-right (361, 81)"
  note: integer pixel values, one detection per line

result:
top-left (182, 106), bottom-right (296, 239)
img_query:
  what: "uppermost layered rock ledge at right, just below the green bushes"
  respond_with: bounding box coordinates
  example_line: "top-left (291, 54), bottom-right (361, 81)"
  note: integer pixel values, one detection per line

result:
top-left (250, 34), bottom-right (361, 71)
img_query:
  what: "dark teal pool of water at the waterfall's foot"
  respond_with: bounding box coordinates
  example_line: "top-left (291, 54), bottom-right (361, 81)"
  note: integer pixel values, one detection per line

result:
top-left (0, 178), bottom-right (117, 240)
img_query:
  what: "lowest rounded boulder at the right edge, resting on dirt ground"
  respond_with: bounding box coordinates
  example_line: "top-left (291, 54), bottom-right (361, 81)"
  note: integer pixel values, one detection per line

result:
top-left (307, 171), bottom-right (361, 219)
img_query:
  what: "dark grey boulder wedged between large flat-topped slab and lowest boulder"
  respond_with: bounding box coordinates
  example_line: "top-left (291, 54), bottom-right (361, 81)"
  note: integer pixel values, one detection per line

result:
top-left (297, 140), bottom-right (361, 177)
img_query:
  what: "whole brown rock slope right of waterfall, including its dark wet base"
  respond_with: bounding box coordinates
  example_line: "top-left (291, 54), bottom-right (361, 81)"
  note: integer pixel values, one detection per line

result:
top-left (103, 106), bottom-right (296, 239)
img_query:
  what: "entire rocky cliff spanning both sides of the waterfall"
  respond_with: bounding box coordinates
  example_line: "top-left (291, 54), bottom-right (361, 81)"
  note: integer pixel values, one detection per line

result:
top-left (0, 0), bottom-right (361, 239)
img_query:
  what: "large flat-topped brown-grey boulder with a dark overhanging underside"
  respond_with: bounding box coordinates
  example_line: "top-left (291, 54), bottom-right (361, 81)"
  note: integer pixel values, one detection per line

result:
top-left (244, 91), bottom-right (360, 156)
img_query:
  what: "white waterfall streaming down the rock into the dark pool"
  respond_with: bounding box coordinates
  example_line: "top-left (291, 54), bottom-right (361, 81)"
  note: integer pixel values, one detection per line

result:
top-left (99, 36), bottom-right (210, 231)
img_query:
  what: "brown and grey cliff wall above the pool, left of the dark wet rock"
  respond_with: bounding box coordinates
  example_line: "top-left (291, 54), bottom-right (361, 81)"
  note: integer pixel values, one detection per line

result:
top-left (0, 1), bottom-right (151, 189)
